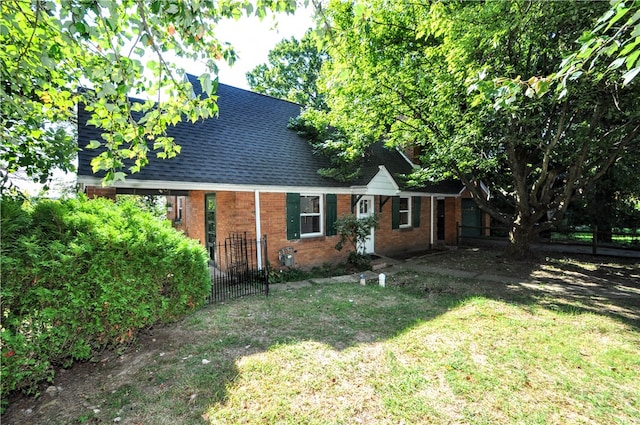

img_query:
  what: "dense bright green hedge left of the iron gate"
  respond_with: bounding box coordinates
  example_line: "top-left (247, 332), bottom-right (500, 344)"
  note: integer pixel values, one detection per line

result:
top-left (0, 198), bottom-right (211, 399)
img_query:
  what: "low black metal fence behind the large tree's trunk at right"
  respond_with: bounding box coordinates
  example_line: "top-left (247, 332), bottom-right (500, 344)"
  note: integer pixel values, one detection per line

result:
top-left (457, 223), bottom-right (640, 255)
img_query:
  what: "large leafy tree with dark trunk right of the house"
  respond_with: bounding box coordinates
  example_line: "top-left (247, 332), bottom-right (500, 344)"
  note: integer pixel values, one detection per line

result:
top-left (322, 0), bottom-right (640, 257)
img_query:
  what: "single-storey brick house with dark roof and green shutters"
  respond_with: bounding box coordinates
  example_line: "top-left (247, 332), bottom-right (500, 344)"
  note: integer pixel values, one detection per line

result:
top-left (78, 77), bottom-right (480, 267)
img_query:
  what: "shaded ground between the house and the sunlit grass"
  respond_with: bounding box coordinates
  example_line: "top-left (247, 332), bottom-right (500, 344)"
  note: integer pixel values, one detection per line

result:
top-left (2, 252), bottom-right (640, 424)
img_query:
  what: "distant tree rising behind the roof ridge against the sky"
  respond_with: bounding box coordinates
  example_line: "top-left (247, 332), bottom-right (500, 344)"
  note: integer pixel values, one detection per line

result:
top-left (247, 30), bottom-right (328, 110)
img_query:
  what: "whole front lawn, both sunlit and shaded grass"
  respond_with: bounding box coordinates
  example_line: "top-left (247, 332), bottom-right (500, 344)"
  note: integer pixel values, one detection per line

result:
top-left (35, 273), bottom-right (640, 424)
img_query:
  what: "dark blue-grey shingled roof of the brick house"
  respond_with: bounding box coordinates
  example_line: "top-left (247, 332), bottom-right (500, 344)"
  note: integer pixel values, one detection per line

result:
top-left (78, 76), bottom-right (460, 194)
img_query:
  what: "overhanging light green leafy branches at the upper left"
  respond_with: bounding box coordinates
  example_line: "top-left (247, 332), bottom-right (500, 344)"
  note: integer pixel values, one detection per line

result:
top-left (0, 0), bottom-right (296, 189)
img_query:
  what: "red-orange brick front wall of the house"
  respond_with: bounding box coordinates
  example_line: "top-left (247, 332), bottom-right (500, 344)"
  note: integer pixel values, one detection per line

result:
top-left (178, 191), bottom-right (468, 267)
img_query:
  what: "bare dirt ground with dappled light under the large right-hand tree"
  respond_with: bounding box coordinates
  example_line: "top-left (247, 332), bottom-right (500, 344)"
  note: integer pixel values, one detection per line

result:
top-left (404, 248), bottom-right (640, 326)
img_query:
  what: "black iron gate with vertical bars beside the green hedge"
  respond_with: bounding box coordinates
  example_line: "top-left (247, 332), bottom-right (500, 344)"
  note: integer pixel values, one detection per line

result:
top-left (207, 233), bottom-right (269, 303)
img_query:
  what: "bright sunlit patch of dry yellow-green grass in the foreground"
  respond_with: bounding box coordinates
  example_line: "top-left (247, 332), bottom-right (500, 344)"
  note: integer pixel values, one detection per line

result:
top-left (206, 298), bottom-right (640, 424)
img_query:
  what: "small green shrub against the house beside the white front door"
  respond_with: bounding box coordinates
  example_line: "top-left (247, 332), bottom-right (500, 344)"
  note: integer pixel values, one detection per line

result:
top-left (335, 214), bottom-right (380, 268)
